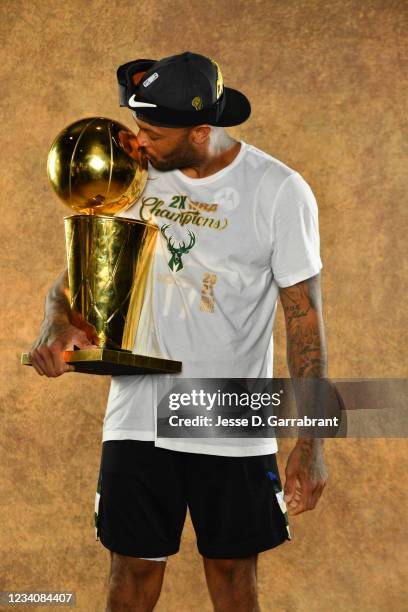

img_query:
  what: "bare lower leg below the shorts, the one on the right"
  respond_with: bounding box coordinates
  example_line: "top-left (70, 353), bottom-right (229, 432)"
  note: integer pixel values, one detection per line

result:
top-left (203, 555), bottom-right (260, 612)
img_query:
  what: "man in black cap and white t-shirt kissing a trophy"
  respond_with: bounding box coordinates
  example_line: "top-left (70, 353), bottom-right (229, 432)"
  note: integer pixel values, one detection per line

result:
top-left (30, 53), bottom-right (327, 612)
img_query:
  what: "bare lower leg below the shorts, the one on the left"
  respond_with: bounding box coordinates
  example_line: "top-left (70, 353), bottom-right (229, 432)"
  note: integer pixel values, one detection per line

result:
top-left (106, 551), bottom-right (166, 612)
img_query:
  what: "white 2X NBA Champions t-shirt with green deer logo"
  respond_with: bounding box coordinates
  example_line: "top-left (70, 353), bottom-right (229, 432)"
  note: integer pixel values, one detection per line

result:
top-left (102, 141), bottom-right (322, 456)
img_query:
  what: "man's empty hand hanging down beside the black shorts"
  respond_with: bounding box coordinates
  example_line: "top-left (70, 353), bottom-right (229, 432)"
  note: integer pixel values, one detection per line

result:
top-left (284, 438), bottom-right (328, 515)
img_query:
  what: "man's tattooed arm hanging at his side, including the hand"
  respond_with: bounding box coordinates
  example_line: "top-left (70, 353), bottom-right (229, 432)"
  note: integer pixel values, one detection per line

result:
top-left (279, 274), bottom-right (328, 515)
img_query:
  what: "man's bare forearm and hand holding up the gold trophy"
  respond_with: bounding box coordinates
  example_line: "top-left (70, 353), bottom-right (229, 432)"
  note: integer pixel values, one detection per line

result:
top-left (29, 269), bottom-right (99, 377)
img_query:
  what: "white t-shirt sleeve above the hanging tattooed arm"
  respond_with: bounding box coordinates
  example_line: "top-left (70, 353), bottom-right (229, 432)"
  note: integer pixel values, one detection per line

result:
top-left (271, 172), bottom-right (323, 288)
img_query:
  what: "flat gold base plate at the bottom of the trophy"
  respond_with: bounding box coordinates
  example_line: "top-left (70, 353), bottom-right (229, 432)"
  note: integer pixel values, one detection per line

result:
top-left (21, 348), bottom-right (182, 376)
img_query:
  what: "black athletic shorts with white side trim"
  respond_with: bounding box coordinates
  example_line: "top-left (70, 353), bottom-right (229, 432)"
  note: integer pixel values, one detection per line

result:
top-left (95, 440), bottom-right (290, 559)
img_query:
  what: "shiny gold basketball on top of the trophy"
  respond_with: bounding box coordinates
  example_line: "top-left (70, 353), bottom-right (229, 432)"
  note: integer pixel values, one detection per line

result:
top-left (47, 117), bottom-right (147, 215)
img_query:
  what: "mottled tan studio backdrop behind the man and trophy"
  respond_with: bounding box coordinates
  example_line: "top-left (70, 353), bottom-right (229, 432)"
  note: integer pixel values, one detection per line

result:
top-left (0, 0), bottom-right (408, 612)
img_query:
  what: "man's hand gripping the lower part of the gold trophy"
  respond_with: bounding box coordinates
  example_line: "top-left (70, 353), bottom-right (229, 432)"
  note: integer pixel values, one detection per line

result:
top-left (28, 311), bottom-right (99, 378)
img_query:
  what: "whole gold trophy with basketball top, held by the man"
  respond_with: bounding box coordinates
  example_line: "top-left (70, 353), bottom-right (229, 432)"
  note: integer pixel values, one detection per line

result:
top-left (21, 117), bottom-right (181, 375)
